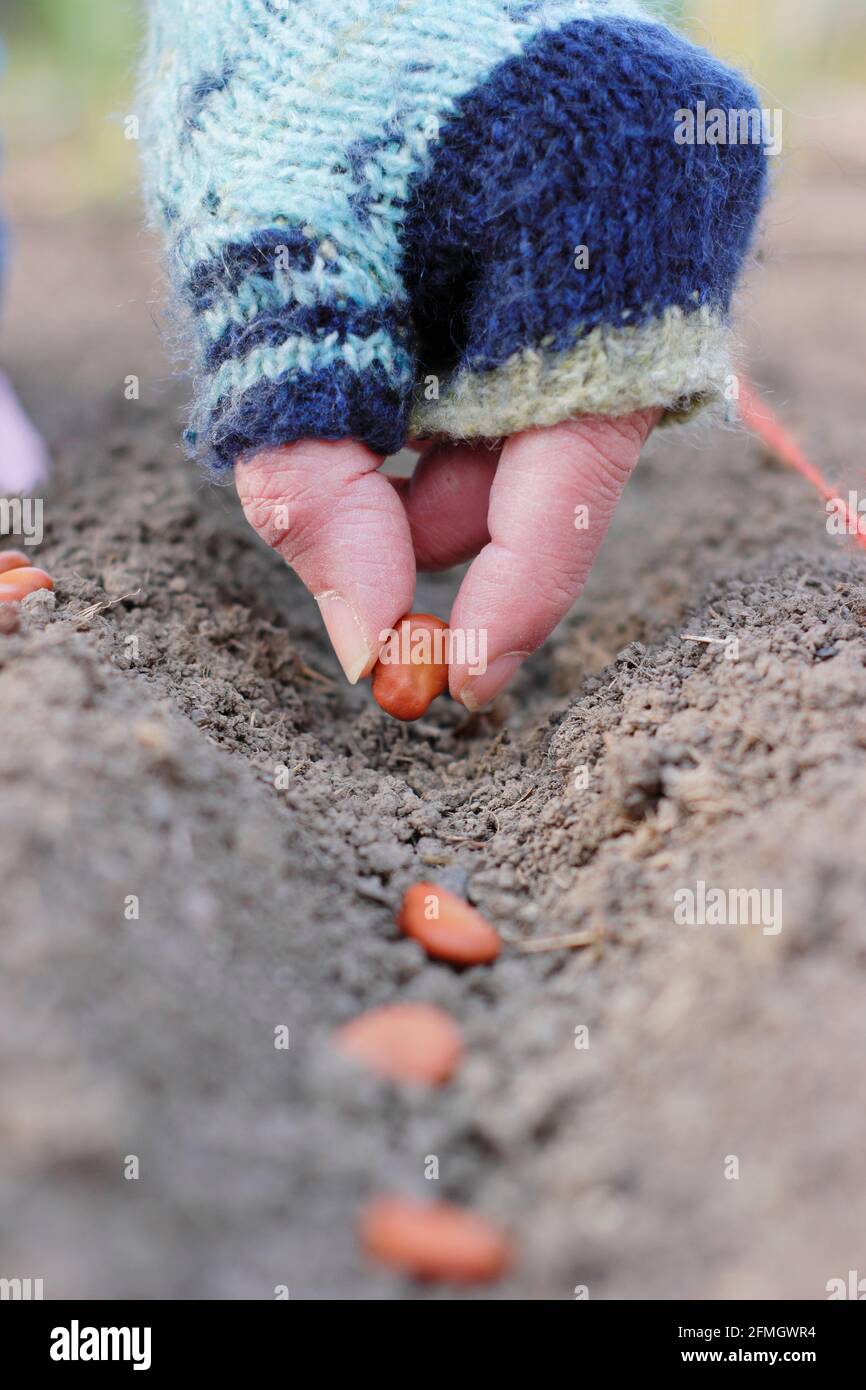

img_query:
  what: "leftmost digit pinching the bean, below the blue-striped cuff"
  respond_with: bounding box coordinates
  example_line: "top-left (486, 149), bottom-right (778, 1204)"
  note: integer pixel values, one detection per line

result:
top-left (235, 439), bottom-right (416, 684)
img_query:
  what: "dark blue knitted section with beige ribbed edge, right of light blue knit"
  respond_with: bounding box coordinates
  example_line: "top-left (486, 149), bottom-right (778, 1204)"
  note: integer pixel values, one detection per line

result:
top-left (405, 19), bottom-right (767, 435)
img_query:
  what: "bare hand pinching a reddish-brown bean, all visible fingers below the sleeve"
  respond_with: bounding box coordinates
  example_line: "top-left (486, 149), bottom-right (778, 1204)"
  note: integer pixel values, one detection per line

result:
top-left (235, 410), bottom-right (660, 710)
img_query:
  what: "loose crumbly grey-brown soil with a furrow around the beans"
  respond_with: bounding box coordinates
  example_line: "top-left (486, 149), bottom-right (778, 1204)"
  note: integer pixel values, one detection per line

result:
top-left (0, 157), bottom-right (866, 1300)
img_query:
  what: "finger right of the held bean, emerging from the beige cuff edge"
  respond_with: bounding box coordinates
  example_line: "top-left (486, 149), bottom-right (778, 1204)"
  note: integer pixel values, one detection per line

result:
top-left (450, 410), bottom-right (660, 710)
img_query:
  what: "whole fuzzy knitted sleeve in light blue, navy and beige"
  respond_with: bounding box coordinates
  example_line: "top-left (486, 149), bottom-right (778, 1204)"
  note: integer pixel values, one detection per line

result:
top-left (142, 0), bottom-right (766, 468)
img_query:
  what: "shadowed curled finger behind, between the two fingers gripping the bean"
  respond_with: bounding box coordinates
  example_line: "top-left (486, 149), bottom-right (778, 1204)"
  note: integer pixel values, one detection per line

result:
top-left (392, 443), bottom-right (500, 570)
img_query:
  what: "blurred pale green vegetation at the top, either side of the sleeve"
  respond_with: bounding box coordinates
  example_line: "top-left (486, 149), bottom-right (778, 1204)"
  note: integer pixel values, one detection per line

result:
top-left (0, 0), bottom-right (866, 215)
